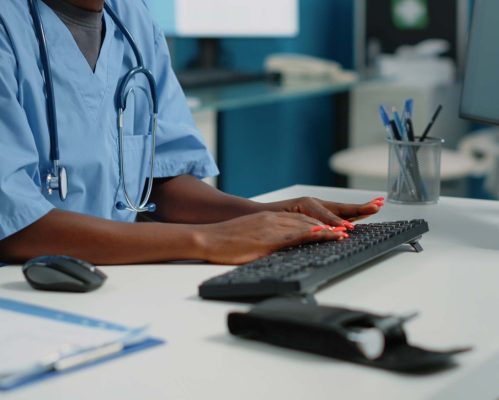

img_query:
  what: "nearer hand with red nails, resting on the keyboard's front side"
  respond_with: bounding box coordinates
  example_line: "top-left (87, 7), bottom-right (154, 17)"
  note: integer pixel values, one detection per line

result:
top-left (196, 211), bottom-right (348, 265)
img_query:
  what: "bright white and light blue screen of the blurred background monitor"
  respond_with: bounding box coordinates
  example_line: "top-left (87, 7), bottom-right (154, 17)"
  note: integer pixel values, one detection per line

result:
top-left (146, 0), bottom-right (299, 38)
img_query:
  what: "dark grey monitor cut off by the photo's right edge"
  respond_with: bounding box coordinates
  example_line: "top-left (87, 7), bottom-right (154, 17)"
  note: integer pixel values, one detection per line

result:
top-left (461, 0), bottom-right (499, 125)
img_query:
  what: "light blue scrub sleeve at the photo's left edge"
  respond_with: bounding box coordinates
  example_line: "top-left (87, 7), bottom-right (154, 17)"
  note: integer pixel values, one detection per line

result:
top-left (0, 23), bottom-right (54, 240)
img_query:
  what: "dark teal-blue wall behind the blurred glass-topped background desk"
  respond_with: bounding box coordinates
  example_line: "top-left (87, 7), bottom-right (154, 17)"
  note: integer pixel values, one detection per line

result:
top-left (219, 0), bottom-right (353, 196)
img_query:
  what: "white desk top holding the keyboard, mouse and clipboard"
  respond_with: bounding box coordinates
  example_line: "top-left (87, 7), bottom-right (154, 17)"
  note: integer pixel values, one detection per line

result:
top-left (0, 186), bottom-right (499, 400)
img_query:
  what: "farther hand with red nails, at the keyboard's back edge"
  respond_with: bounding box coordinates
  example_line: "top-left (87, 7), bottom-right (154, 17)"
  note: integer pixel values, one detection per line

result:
top-left (269, 197), bottom-right (385, 229)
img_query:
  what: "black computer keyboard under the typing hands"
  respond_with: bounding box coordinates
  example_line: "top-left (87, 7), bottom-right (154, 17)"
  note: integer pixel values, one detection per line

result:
top-left (199, 220), bottom-right (428, 300)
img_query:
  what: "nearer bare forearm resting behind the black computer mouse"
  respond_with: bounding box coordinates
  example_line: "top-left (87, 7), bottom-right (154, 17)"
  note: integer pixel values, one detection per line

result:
top-left (0, 210), bottom-right (202, 265)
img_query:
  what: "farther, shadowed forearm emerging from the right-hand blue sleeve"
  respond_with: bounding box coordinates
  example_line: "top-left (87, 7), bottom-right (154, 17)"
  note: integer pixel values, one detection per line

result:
top-left (147, 175), bottom-right (267, 224)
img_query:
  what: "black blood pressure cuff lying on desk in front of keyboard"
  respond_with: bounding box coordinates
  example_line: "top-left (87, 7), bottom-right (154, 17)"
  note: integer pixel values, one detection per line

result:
top-left (228, 298), bottom-right (470, 373)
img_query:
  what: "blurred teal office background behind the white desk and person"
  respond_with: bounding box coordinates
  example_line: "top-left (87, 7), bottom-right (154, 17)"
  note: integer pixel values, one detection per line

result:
top-left (146, 0), bottom-right (499, 198)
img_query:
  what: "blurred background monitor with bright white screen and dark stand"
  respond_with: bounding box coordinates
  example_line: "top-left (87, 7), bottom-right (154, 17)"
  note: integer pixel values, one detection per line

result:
top-left (146, 0), bottom-right (300, 88)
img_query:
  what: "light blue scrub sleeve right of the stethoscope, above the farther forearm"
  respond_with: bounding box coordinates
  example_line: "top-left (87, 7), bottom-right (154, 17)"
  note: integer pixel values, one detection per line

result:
top-left (148, 27), bottom-right (218, 179)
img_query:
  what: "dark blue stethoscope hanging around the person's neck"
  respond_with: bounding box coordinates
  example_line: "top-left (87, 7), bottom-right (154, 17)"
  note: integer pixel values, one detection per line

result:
top-left (28, 0), bottom-right (158, 213)
